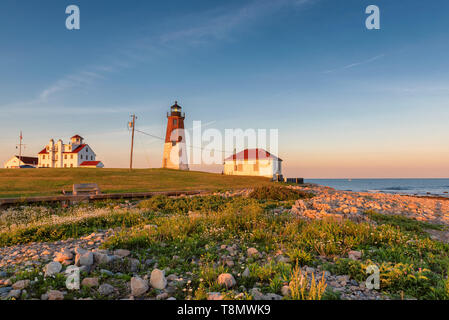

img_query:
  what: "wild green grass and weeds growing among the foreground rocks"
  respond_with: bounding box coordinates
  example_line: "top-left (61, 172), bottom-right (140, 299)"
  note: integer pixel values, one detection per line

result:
top-left (0, 190), bottom-right (449, 299)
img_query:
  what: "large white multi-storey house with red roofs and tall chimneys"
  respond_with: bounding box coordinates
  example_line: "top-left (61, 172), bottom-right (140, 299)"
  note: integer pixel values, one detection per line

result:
top-left (38, 135), bottom-right (104, 168)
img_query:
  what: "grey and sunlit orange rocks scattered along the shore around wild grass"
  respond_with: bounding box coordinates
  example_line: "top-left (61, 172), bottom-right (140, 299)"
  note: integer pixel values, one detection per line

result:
top-left (0, 185), bottom-right (449, 300)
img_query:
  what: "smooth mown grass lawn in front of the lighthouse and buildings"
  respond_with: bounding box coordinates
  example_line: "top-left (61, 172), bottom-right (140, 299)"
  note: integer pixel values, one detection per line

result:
top-left (0, 168), bottom-right (270, 198)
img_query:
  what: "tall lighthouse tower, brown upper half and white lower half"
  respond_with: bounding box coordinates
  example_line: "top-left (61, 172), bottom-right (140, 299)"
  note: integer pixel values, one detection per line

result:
top-left (162, 101), bottom-right (189, 170)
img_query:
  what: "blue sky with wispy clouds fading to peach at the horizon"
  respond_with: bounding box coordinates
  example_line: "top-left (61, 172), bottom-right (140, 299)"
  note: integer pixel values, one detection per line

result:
top-left (0, 0), bottom-right (449, 178)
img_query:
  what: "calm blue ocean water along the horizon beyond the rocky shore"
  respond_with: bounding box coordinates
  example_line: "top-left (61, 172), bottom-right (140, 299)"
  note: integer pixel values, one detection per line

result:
top-left (305, 179), bottom-right (449, 197)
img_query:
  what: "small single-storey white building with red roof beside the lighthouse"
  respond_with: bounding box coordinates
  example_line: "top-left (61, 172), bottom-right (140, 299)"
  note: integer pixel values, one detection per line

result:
top-left (224, 148), bottom-right (282, 178)
